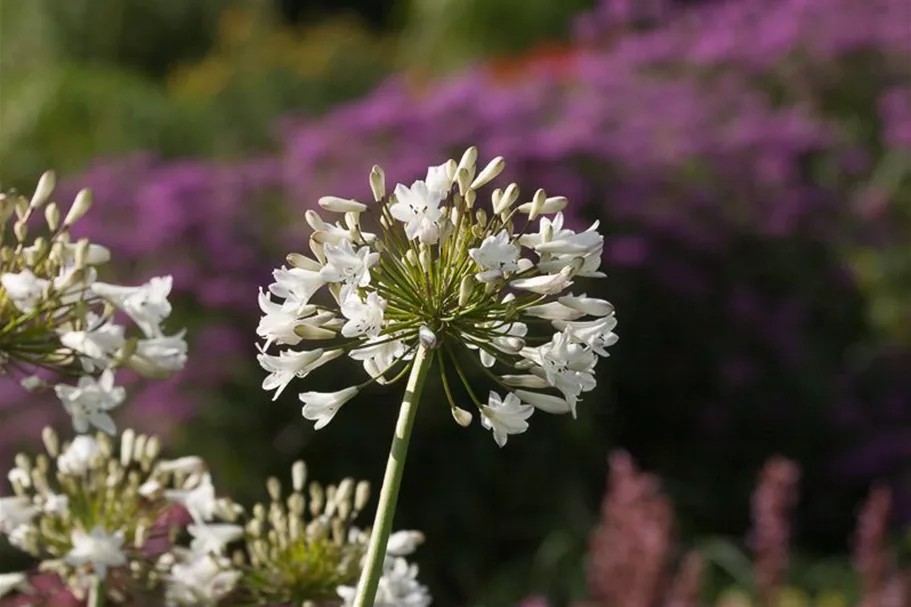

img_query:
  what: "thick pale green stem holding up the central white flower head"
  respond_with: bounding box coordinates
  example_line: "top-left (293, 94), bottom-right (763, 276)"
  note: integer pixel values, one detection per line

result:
top-left (354, 346), bottom-right (433, 607)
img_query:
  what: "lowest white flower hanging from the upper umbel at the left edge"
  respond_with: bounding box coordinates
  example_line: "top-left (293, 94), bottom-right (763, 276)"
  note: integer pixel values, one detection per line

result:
top-left (54, 369), bottom-right (126, 434)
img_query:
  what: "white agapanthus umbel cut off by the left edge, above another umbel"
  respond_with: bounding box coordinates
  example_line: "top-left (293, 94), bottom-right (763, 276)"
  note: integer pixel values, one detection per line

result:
top-left (0, 172), bottom-right (187, 434)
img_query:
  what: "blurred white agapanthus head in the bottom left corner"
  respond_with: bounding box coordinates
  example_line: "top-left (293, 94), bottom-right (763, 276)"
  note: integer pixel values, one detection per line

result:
top-left (0, 428), bottom-right (244, 606)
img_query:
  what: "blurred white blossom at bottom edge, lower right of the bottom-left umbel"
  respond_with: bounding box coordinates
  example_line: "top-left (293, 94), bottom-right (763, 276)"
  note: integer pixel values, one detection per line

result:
top-left (167, 553), bottom-right (240, 607)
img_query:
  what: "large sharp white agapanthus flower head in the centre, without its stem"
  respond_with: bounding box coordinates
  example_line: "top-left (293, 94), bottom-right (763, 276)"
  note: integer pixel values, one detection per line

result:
top-left (257, 148), bottom-right (617, 446)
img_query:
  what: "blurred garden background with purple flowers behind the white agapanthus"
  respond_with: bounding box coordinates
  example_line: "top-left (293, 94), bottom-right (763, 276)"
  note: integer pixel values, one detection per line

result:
top-left (0, 0), bottom-right (911, 607)
